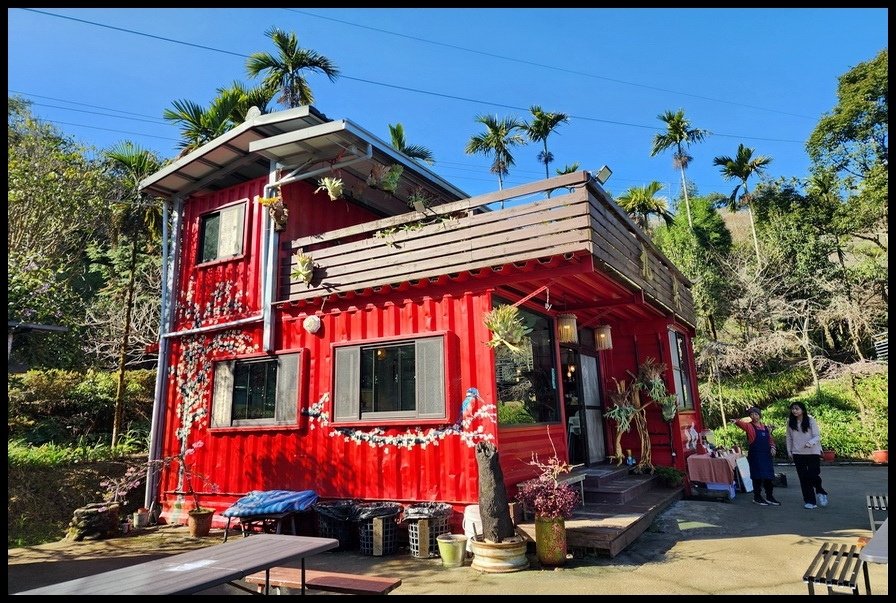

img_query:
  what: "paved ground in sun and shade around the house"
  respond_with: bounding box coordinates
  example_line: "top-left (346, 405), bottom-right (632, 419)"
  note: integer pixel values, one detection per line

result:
top-left (7, 465), bottom-right (889, 595)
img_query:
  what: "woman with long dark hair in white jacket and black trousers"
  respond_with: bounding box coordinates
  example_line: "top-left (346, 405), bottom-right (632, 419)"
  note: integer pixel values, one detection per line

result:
top-left (787, 402), bottom-right (828, 509)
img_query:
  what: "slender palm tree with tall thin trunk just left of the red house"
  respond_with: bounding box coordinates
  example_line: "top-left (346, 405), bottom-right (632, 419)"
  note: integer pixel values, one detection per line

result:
top-left (104, 141), bottom-right (162, 447)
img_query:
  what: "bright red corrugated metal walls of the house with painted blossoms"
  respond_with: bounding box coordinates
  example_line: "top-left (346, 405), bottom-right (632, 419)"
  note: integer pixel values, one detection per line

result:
top-left (161, 179), bottom-right (700, 511)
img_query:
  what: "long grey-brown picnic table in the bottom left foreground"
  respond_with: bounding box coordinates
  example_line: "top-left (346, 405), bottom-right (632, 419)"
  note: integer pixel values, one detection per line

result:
top-left (16, 534), bottom-right (339, 595)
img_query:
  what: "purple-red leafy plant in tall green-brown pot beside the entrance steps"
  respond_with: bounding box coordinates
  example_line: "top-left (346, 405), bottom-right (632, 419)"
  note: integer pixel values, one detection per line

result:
top-left (517, 453), bottom-right (579, 566)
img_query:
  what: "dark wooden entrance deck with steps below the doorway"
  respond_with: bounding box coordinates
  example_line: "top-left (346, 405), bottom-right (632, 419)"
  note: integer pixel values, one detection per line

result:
top-left (517, 466), bottom-right (683, 557)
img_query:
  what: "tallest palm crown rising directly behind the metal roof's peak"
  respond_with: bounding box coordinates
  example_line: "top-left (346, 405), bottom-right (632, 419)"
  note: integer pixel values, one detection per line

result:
top-left (246, 27), bottom-right (339, 108)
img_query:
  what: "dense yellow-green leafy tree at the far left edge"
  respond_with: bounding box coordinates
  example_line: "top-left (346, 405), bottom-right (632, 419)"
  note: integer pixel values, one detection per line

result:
top-left (7, 97), bottom-right (111, 368)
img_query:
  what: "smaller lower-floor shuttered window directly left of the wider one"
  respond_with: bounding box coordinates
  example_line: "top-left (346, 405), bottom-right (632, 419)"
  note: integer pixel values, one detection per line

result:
top-left (212, 353), bottom-right (300, 427)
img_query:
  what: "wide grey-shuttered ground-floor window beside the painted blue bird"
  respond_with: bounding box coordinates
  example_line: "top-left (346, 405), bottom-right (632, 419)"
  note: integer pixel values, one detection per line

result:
top-left (333, 336), bottom-right (447, 423)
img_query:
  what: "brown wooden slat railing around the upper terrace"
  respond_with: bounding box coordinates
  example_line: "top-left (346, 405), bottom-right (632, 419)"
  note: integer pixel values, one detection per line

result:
top-left (278, 172), bottom-right (695, 324)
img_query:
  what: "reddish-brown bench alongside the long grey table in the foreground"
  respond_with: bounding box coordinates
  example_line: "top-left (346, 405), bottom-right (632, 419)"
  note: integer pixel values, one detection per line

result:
top-left (243, 567), bottom-right (401, 595)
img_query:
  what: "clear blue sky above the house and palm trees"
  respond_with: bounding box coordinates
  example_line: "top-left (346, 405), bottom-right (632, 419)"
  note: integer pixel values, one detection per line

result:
top-left (7, 8), bottom-right (889, 199)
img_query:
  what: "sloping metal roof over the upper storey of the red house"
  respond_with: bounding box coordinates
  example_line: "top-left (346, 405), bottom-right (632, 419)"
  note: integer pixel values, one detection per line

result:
top-left (140, 105), bottom-right (468, 202)
